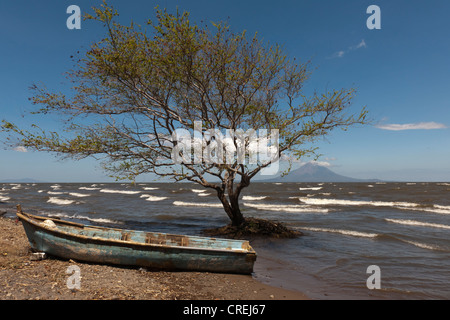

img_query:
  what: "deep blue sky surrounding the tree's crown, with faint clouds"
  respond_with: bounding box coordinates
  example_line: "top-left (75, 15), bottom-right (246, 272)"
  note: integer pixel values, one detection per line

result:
top-left (0, 0), bottom-right (450, 182)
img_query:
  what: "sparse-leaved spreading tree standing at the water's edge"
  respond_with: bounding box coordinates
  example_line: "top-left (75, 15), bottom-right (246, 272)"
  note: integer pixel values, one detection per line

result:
top-left (2, 3), bottom-right (366, 234)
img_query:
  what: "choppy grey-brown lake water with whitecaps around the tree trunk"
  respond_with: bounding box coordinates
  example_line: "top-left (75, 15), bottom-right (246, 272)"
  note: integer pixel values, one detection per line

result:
top-left (0, 183), bottom-right (450, 299)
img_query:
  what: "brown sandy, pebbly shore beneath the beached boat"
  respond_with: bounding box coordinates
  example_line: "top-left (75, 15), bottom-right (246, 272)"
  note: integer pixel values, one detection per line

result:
top-left (0, 218), bottom-right (308, 300)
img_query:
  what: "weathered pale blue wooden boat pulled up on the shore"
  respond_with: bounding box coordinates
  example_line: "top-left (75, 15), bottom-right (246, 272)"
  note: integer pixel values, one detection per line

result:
top-left (17, 205), bottom-right (256, 274)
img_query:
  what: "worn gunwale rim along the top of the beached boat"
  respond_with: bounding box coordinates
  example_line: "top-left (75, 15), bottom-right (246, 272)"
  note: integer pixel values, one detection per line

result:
top-left (16, 211), bottom-right (256, 255)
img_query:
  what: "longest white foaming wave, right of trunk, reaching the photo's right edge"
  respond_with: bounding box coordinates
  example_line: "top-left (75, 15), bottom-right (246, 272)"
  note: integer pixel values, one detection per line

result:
top-left (299, 197), bottom-right (450, 214)
